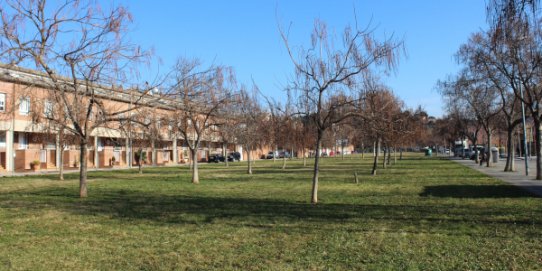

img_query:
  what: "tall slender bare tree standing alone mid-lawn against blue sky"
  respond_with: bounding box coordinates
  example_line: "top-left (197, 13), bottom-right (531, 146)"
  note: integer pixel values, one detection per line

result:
top-left (280, 17), bottom-right (401, 204)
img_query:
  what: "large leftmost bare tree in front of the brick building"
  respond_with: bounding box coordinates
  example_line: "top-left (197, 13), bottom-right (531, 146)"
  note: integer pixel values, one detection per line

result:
top-left (0, 0), bottom-right (150, 197)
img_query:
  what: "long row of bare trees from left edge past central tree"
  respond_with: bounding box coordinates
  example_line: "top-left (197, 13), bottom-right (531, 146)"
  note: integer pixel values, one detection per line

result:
top-left (0, 0), bottom-right (434, 203)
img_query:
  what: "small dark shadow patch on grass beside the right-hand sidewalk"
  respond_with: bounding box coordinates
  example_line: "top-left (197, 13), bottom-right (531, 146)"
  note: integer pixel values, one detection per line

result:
top-left (420, 185), bottom-right (537, 198)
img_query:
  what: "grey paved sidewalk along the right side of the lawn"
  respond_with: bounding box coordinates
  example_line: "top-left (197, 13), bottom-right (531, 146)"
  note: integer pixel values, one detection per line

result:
top-left (450, 158), bottom-right (542, 197)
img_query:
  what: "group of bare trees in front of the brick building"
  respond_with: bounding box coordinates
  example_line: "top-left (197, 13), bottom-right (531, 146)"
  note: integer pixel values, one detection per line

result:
top-left (0, 0), bottom-right (242, 197)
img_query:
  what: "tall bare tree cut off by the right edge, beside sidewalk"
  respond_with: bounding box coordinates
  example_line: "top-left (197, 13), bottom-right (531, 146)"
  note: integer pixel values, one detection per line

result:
top-left (487, 0), bottom-right (542, 180)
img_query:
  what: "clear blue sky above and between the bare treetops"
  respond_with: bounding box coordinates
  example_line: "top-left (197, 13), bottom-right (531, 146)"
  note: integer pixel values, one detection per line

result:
top-left (117, 0), bottom-right (487, 116)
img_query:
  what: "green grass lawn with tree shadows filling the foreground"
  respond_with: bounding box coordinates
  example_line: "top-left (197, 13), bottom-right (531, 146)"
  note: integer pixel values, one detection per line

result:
top-left (0, 156), bottom-right (542, 270)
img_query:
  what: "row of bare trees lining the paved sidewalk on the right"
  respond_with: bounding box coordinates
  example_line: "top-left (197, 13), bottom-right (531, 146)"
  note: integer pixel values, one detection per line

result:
top-left (439, 0), bottom-right (542, 180)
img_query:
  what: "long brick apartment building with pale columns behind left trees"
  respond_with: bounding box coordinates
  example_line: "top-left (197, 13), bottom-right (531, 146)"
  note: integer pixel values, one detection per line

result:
top-left (0, 65), bottom-right (252, 174)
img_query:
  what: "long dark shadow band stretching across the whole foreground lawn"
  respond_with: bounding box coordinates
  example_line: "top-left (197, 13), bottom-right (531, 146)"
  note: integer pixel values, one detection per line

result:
top-left (0, 188), bottom-right (542, 238)
